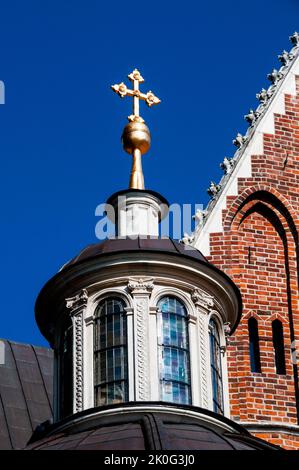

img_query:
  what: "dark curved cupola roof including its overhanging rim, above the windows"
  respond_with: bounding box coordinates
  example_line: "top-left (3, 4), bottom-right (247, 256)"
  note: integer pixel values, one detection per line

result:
top-left (35, 236), bottom-right (242, 344)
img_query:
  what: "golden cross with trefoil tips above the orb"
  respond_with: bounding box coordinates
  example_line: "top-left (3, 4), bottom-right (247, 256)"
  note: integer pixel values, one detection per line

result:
top-left (111, 69), bottom-right (161, 122)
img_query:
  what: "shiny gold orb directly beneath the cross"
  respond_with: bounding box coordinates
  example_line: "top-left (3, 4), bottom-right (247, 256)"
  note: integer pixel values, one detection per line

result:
top-left (121, 121), bottom-right (151, 154)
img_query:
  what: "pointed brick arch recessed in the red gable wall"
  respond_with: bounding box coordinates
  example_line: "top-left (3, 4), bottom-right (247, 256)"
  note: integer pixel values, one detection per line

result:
top-left (223, 184), bottom-right (299, 422)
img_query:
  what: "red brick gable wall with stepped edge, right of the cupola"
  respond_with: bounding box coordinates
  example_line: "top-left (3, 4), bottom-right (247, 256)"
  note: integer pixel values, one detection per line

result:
top-left (210, 76), bottom-right (299, 449)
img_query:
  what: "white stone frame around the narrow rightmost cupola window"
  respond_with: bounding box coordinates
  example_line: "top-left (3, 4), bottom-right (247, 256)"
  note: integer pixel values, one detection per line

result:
top-left (207, 310), bottom-right (230, 418)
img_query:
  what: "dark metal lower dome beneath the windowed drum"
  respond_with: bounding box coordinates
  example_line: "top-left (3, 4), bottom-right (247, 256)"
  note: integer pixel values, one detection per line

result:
top-left (27, 402), bottom-right (277, 450)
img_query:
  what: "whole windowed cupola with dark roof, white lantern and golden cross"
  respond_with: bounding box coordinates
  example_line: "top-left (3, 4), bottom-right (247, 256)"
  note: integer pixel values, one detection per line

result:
top-left (33, 70), bottom-right (276, 449)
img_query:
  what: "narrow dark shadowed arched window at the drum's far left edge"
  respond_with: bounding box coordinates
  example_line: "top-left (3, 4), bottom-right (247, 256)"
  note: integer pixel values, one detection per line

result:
top-left (59, 317), bottom-right (73, 419)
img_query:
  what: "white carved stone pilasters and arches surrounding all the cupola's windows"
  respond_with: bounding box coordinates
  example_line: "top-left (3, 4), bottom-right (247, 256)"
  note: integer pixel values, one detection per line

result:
top-left (73, 278), bottom-right (229, 417)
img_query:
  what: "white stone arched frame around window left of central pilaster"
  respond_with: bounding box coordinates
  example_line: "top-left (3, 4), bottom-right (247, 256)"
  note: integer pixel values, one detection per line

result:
top-left (83, 287), bottom-right (134, 409)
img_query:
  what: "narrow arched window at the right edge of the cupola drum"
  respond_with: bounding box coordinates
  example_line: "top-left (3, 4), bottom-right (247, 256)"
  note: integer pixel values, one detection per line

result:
top-left (209, 318), bottom-right (224, 414)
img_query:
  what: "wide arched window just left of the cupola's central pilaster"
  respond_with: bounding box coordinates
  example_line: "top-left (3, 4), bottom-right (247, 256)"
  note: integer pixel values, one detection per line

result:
top-left (94, 298), bottom-right (128, 406)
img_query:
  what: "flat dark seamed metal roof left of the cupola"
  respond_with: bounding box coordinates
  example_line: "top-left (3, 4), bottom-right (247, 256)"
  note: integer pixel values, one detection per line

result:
top-left (0, 340), bottom-right (53, 450)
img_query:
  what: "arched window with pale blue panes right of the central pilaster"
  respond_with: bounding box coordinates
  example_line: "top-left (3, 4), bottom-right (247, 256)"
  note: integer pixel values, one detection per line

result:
top-left (158, 297), bottom-right (191, 404)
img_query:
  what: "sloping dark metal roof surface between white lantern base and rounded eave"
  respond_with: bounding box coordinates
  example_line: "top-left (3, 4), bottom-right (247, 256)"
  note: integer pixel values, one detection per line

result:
top-left (63, 237), bottom-right (209, 269)
